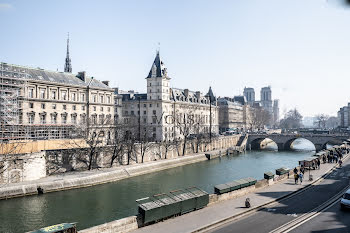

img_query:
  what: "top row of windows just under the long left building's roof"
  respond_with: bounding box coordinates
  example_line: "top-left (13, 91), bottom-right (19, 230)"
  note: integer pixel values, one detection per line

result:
top-left (28, 88), bottom-right (112, 104)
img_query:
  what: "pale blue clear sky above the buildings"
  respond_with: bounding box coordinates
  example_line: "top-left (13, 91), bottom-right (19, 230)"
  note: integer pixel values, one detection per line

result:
top-left (0, 0), bottom-right (350, 116)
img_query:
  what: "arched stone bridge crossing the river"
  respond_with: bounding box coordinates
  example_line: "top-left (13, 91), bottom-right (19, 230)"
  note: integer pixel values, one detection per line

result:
top-left (247, 134), bottom-right (349, 152)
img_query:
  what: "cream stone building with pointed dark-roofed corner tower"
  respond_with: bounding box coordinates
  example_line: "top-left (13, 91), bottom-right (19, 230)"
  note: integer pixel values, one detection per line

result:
top-left (120, 52), bottom-right (219, 141)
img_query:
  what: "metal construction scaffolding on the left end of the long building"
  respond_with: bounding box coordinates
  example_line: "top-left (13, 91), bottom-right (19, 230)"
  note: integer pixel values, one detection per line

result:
top-left (0, 63), bottom-right (76, 142)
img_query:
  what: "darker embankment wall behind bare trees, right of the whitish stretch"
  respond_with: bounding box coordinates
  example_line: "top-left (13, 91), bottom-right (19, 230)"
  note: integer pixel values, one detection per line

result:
top-left (46, 135), bottom-right (240, 175)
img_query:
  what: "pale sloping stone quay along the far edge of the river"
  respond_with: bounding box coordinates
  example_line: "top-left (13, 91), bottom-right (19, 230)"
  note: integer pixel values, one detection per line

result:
top-left (0, 151), bottom-right (219, 199)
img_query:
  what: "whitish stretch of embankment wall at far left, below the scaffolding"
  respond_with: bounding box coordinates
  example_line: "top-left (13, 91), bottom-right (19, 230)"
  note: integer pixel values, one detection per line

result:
top-left (0, 152), bottom-right (46, 184)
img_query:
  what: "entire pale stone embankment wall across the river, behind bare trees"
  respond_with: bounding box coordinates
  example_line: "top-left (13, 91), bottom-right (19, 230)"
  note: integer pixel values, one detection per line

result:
top-left (0, 135), bottom-right (239, 184)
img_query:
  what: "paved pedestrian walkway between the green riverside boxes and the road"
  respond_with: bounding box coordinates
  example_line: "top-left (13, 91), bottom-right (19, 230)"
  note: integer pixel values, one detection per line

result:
top-left (133, 154), bottom-right (350, 233)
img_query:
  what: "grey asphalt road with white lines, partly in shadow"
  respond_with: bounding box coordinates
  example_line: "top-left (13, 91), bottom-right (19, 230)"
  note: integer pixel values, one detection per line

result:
top-left (208, 160), bottom-right (350, 233)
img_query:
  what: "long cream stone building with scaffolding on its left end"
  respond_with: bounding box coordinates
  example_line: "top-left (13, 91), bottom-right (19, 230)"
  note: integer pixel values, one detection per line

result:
top-left (0, 63), bottom-right (114, 140)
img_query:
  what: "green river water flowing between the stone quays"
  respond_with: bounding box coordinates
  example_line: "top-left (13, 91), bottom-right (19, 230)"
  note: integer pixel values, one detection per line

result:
top-left (0, 140), bottom-right (315, 232)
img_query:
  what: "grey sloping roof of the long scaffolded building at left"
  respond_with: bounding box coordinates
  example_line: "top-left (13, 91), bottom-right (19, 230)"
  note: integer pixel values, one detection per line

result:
top-left (0, 63), bottom-right (110, 89)
